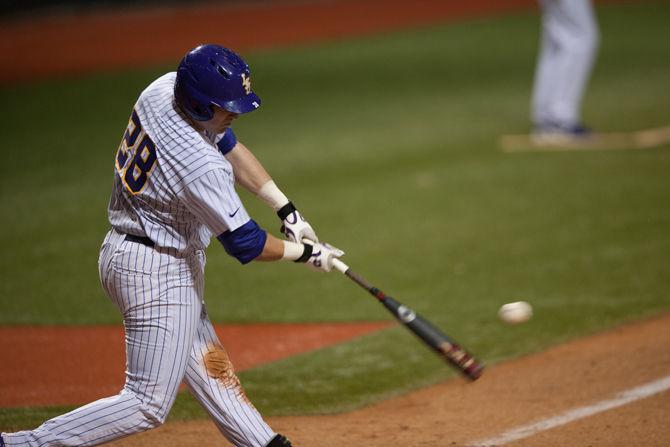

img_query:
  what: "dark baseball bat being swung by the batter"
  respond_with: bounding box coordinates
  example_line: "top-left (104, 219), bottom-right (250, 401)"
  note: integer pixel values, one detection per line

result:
top-left (333, 259), bottom-right (484, 380)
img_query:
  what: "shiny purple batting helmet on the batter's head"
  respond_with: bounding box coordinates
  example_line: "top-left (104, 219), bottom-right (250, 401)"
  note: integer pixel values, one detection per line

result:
top-left (174, 45), bottom-right (261, 121)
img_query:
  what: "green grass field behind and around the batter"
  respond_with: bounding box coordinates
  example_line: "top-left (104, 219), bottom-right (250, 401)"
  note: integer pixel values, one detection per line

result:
top-left (0, 3), bottom-right (670, 428)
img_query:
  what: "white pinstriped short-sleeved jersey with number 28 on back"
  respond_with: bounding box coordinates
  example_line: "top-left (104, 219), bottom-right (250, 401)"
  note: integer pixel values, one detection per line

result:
top-left (108, 72), bottom-right (249, 254)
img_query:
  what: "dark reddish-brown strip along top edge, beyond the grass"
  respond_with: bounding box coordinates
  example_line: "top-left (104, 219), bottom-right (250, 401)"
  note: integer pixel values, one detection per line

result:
top-left (0, 0), bottom-right (535, 83)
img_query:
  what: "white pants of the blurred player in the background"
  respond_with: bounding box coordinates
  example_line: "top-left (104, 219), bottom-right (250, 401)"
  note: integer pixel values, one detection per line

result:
top-left (532, 0), bottom-right (599, 136)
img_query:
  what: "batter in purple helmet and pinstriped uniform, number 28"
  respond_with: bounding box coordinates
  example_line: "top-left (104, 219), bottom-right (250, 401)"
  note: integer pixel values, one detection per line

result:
top-left (0, 45), bottom-right (344, 447)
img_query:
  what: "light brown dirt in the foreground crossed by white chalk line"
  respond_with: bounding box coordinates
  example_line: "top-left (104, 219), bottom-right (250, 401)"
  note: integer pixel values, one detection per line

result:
top-left (114, 314), bottom-right (670, 447)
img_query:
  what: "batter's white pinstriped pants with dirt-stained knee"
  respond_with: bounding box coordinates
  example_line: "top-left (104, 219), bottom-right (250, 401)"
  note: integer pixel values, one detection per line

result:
top-left (3, 230), bottom-right (275, 447)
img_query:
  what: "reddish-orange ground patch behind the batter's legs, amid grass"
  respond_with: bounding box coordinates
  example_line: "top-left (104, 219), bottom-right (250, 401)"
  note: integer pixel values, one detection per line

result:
top-left (0, 322), bottom-right (391, 408)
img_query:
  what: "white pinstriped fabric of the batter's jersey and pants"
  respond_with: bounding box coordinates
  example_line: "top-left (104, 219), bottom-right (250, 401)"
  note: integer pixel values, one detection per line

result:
top-left (3, 73), bottom-right (275, 447)
